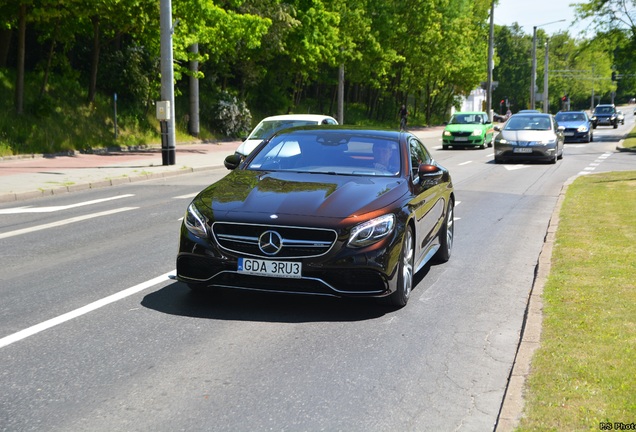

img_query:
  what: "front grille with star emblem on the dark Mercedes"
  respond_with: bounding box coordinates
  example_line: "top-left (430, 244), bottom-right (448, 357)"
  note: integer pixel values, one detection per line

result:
top-left (212, 222), bottom-right (337, 259)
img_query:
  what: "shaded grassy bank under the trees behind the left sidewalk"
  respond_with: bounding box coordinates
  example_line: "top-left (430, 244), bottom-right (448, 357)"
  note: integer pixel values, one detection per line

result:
top-left (0, 69), bottom-right (158, 156)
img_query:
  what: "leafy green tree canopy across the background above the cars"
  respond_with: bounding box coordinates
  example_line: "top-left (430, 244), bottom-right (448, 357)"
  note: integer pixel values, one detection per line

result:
top-left (0, 0), bottom-right (624, 154)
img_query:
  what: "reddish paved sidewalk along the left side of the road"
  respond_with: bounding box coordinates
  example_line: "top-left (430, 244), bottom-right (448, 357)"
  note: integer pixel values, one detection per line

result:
top-left (0, 141), bottom-right (240, 202)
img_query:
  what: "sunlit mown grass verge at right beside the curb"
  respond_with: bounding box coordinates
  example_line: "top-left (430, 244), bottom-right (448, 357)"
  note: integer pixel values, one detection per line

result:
top-left (517, 171), bottom-right (636, 431)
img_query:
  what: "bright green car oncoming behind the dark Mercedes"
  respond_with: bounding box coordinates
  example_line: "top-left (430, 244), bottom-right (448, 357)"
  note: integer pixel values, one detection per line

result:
top-left (442, 111), bottom-right (495, 150)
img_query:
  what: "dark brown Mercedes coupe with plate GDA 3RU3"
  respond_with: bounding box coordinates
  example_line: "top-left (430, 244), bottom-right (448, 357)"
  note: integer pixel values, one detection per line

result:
top-left (177, 126), bottom-right (455, 307)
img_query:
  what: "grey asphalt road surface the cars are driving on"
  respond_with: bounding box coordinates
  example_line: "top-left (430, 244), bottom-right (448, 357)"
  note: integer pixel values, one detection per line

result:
top-left (0, 115), bottom-right (636, 431)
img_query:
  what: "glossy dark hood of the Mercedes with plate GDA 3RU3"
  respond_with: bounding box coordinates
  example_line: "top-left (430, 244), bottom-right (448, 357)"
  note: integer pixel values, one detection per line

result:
top-left (197, 170), bottom-right (408, 223)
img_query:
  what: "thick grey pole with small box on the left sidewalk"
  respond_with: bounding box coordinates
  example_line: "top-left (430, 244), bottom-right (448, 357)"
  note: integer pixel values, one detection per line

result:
top-left (159, 0), bottom-right (177, 165)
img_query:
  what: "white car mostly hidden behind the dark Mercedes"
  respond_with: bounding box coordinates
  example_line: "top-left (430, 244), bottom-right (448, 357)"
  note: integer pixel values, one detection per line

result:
top-left (236, 114), bottom-right (338, 157)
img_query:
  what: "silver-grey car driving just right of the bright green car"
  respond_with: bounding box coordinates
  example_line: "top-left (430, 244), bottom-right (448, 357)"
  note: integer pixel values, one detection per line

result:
top-left (494, 113), bottom-right (565, 163)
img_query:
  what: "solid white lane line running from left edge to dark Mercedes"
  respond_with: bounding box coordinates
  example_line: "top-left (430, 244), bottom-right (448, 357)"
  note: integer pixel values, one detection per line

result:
top-left (0, 270), bottom-right (176, 348)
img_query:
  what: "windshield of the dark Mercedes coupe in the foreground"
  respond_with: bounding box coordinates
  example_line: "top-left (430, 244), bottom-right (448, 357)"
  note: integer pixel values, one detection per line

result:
top-left (247, 131), bottom-right (401, 177)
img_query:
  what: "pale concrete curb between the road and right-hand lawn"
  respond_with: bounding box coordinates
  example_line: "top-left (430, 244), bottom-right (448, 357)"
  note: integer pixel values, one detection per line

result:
top-left (494, 176), bottom-right (578, 432)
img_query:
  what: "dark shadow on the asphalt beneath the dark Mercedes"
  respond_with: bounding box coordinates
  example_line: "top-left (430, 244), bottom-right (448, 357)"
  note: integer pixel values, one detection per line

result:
top-left (141, 266), bottom-right (428, 323)
